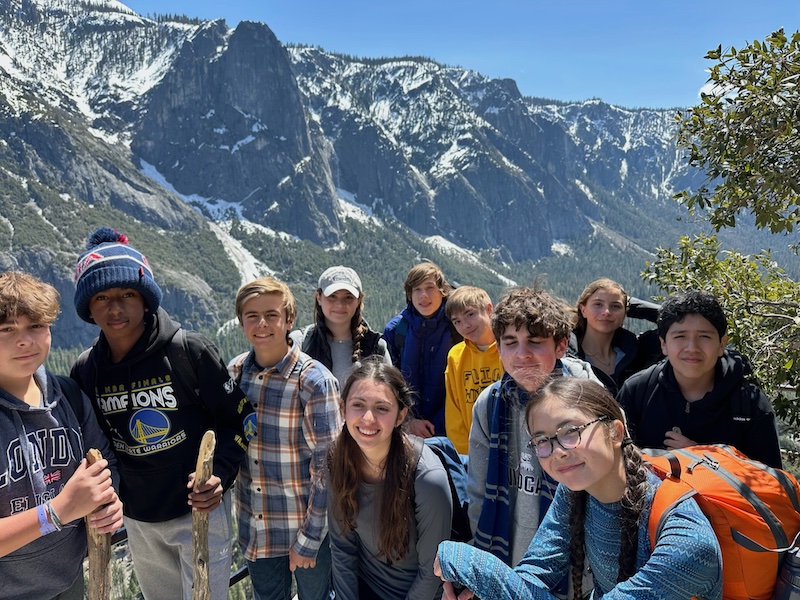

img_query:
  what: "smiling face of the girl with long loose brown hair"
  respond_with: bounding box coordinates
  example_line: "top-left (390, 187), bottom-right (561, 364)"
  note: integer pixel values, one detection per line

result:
top-left (344, 379), bottom-right (408, 464)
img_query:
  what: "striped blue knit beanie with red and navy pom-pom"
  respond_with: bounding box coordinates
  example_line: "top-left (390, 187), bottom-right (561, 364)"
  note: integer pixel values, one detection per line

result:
top-left (75, 227), bottom-right (161, 323)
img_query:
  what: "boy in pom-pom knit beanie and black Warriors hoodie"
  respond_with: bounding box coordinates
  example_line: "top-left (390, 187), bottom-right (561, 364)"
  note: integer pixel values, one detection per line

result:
top-left (71, 228), bottom-right (254, 600)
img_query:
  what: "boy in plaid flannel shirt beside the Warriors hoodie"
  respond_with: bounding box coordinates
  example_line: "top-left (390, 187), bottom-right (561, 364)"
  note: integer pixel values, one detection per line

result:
top-left (228, 277), bottom-right (342, 600)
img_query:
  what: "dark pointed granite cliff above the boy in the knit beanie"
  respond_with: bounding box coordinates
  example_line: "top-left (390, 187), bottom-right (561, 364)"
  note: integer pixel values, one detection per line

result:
top-left (131, 22), bottom-right (339, 244)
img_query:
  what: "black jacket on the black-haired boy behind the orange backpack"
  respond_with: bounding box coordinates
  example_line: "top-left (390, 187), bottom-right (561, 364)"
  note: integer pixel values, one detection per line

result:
top-left (617, 350), bottom-right (781, 467)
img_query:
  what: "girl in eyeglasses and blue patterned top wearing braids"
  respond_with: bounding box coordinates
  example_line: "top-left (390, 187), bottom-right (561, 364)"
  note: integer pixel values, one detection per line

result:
top-left (434, 377), bottom-right (722, 600)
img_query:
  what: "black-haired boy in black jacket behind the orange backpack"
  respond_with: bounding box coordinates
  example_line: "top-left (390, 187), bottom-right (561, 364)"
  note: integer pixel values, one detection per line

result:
top-left (617, 291), bottom-right (781, 467)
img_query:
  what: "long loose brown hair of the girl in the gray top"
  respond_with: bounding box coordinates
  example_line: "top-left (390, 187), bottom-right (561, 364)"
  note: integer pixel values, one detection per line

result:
top-left (328, 356), bottom-right (416, 563)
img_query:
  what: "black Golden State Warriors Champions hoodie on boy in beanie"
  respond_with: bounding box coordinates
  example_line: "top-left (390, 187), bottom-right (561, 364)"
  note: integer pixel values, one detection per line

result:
top-left (71, 309), bottom-right (254, 523)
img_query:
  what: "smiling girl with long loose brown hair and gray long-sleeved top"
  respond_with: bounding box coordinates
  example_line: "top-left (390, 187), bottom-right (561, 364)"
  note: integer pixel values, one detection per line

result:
top-left (328, 357), bottom-right (452, 600)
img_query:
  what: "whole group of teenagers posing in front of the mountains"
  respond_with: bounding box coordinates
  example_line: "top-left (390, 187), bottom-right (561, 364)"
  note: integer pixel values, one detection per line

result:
top-left (0, 228), bottom-right (781, 600)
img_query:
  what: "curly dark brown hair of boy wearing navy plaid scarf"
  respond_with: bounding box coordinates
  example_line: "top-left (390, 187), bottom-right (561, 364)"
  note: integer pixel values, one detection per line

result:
top-left (492, 287), bottom-right (572, 345)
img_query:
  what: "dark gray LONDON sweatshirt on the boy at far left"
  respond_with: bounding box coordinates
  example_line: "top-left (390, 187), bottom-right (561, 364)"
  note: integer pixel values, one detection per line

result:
top-left (0, 367), bottom-right (116, 600)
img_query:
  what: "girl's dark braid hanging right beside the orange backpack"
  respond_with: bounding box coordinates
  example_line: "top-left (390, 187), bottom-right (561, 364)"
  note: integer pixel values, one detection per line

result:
top-left (617, 440), bottom-right (647, 582)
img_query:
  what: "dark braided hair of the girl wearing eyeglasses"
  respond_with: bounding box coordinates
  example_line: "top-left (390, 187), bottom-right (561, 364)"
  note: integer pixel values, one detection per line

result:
top-left (525, 377), bottom-right (648, 599)
